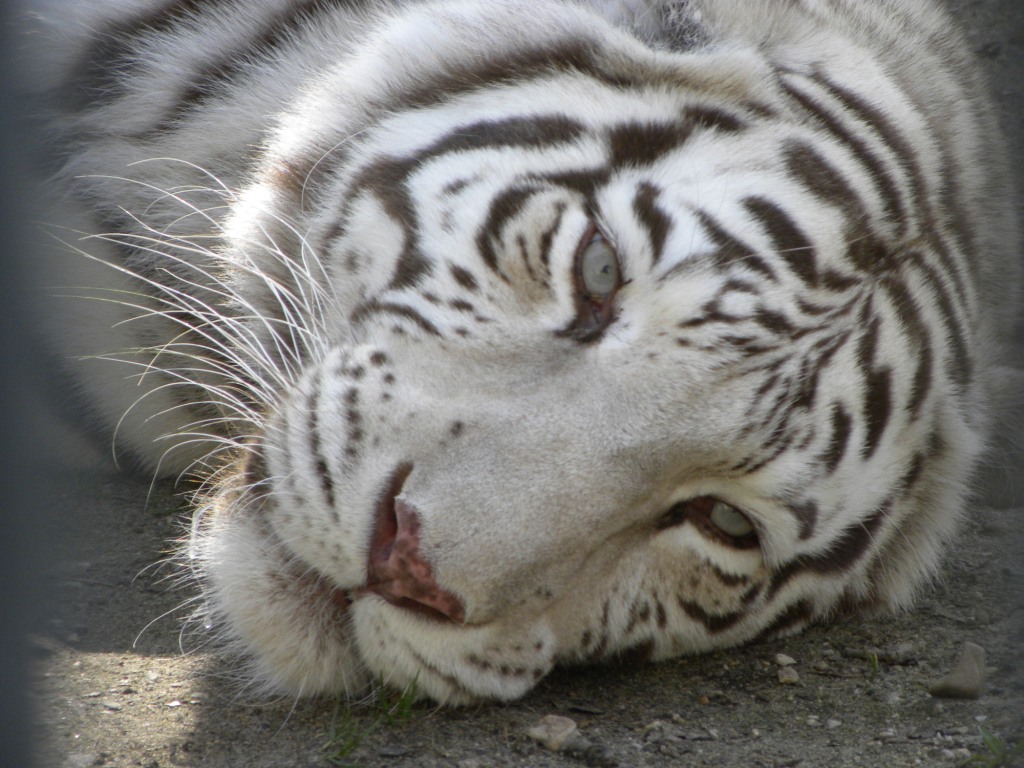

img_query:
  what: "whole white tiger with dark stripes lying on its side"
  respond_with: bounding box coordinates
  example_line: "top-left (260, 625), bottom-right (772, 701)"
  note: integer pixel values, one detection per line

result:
top-left (34, 0), bottom-right (1017, 705)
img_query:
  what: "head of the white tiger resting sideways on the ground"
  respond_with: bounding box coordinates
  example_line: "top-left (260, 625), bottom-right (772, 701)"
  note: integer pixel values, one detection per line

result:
top-left (190, 2), bottom-right (979, 703)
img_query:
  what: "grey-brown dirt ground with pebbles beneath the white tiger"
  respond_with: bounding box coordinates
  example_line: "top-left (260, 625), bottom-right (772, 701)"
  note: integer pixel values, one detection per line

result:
top-left (14, 0), bottom-right (1024, 768)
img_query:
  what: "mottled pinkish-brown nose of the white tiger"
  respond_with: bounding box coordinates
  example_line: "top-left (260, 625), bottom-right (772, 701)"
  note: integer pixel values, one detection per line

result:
top-left (366, 499), bottom-right (466, 623)
